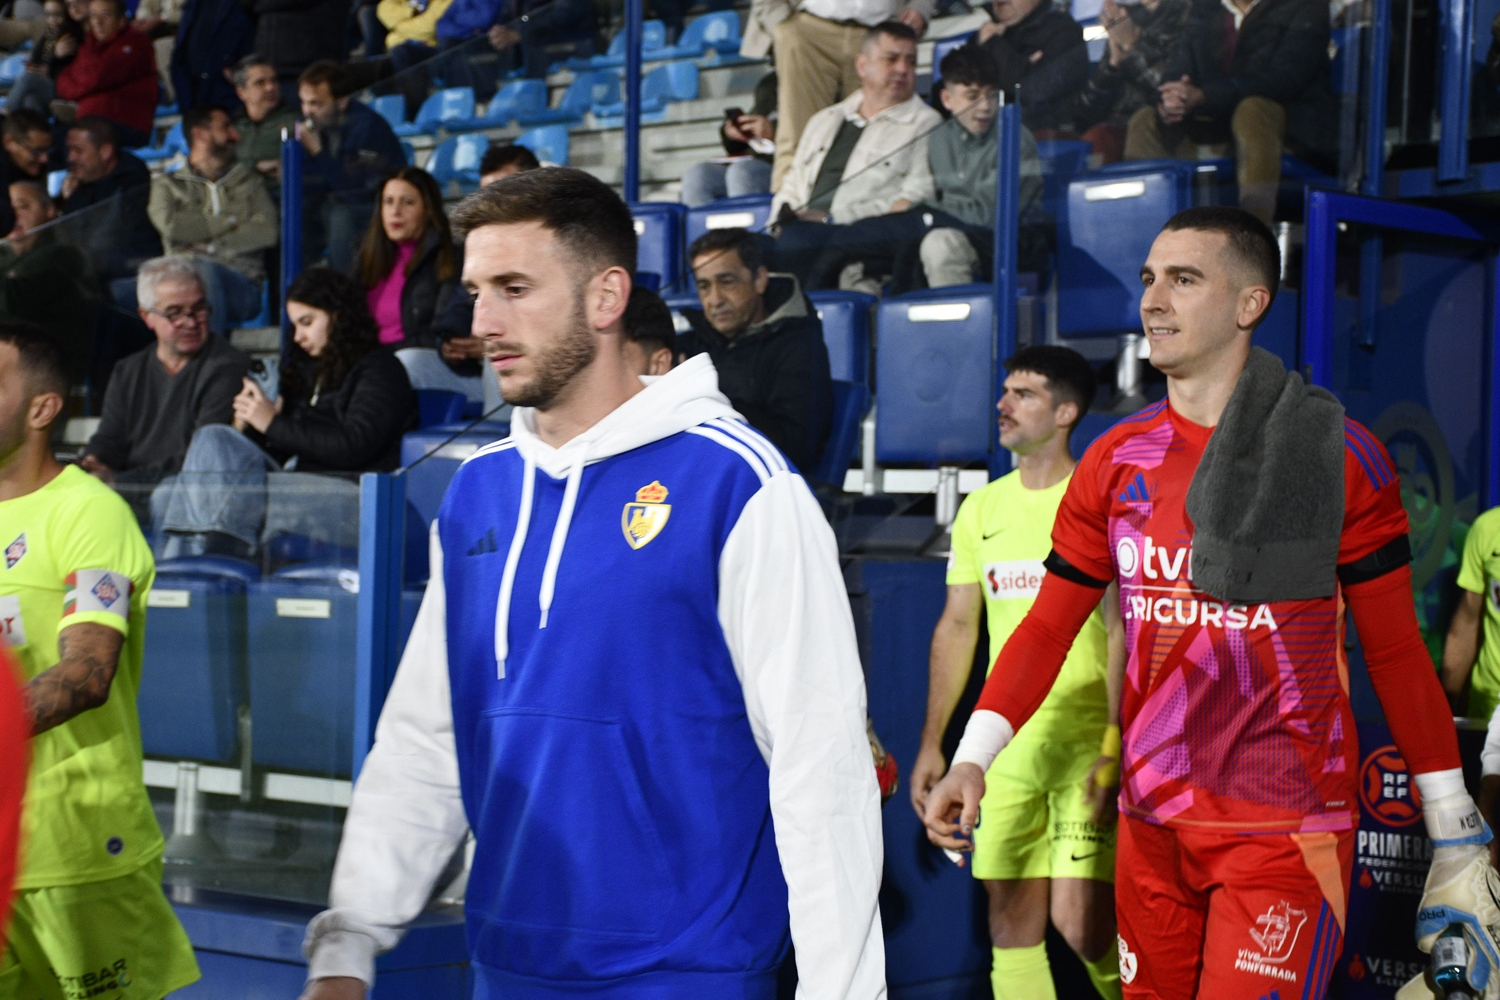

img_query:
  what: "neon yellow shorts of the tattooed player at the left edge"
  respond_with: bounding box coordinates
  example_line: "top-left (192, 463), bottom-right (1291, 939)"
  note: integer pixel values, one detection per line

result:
top-left (0, 859), bottom-right (198, 1000)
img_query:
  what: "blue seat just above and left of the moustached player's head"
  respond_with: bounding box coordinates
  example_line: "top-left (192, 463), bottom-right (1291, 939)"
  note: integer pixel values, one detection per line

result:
top-left (875, 285), bottom-right (995, 466)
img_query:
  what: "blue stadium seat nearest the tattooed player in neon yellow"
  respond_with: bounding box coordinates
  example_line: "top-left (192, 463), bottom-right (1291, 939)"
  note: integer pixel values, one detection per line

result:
top-left (137, 556), bottom-right (260, 763)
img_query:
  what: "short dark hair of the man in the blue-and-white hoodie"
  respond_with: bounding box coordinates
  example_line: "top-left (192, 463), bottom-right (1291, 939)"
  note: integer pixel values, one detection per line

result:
top-left (453, 166), bottom-right (636, 274)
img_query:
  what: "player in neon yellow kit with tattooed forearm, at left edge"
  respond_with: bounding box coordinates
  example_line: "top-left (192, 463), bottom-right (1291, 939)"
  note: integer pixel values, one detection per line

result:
top-left (0, 321), bottom-right (198, 1000)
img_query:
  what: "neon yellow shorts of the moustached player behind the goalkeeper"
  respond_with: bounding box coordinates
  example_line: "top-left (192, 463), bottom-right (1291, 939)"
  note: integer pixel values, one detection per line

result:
top-left (972, 739), bottom-right (1115, 882)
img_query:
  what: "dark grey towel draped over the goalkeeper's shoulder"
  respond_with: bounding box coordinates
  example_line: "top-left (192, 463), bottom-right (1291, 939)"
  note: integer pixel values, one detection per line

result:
top-left (1187, 348), bottom-right (1344, 604)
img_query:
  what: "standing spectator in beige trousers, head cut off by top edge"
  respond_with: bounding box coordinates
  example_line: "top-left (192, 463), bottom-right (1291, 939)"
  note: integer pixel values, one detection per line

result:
top-left (762, 0), bottom-right (933, 190)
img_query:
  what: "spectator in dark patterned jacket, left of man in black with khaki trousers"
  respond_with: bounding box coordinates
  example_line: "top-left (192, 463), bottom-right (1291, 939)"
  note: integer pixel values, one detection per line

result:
top-left (1064, 0), bottom-right (1188, 163)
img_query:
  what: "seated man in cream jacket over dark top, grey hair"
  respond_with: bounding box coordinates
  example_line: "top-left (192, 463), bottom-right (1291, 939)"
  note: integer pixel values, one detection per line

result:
top-left (771, 21), bottom-right (942, 286)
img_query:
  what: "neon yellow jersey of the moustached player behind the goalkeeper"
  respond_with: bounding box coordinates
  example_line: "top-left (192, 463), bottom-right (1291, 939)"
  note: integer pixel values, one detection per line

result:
top-left (948, 472), bottom-right (1109, 742)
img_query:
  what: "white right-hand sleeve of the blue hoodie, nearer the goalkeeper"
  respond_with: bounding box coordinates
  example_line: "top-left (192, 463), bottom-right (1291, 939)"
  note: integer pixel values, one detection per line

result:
top-left (719, 472), bottom-right (885, 1000)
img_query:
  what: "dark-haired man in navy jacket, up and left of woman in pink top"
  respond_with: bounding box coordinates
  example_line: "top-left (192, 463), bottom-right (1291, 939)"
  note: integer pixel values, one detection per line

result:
top-left (297, 61), bottom-right (407, 274)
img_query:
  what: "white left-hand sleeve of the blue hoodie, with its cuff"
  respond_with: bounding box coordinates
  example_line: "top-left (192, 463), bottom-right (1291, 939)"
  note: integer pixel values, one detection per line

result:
top-left (303, 525), bottom-right (468, 984)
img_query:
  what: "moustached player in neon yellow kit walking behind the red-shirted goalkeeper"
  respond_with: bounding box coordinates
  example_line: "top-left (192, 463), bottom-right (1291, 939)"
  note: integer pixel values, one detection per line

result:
top-left (911, 346), bottom-right (1124, 1000)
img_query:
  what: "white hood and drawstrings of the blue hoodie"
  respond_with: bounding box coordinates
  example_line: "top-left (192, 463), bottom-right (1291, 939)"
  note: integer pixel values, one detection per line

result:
top-left (495, 355), bottom-right (738, 678)
